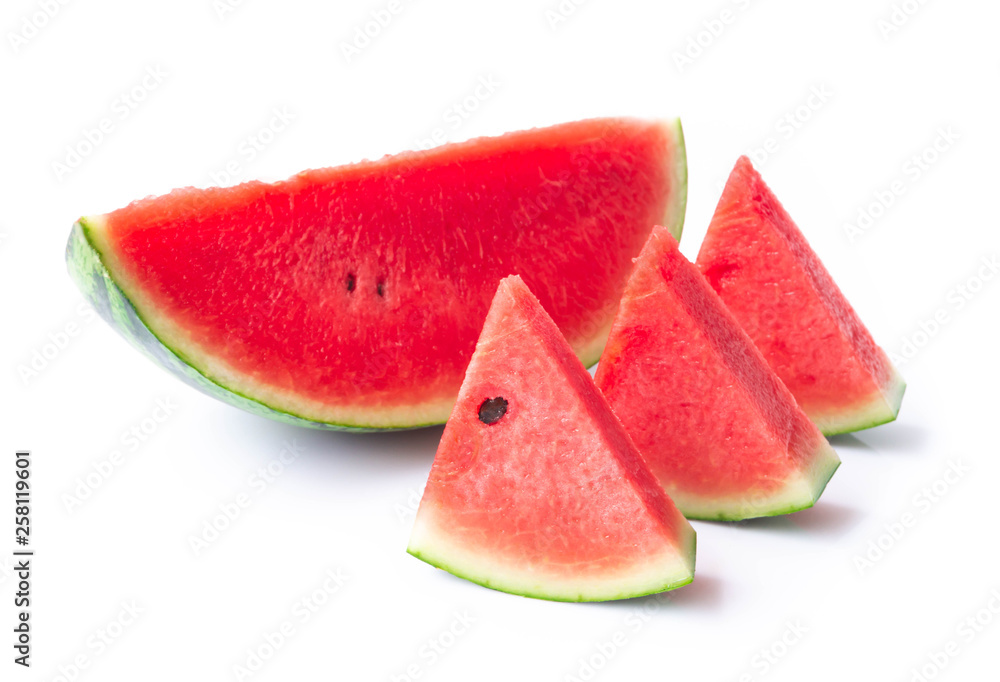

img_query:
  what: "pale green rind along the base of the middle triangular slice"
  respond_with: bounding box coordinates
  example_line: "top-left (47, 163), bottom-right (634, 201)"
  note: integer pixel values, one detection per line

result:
top-left (674, 439), bottom-right (841, 521)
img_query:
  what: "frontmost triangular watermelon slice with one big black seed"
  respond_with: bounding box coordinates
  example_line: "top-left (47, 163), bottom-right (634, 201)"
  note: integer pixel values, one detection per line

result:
top-left (408, 276), bottom-right (695, 601)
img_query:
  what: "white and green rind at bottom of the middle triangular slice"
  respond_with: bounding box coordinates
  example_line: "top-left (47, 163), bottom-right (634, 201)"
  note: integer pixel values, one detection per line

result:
top-left (669, 439), bottom-right (840, 521)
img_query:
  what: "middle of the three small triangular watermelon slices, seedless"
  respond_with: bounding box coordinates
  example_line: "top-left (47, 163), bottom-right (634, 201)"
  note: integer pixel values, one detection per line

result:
top-left (596, 227), bottom-right (840, 521)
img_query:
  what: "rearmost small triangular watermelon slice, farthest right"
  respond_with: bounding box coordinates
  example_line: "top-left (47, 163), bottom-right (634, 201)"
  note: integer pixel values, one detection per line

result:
top-left (697, 156), bottom-right (906, 436)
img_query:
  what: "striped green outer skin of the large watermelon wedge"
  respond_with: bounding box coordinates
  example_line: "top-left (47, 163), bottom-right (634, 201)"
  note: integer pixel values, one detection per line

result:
top-left (66, 219), bottom-right (420, 432)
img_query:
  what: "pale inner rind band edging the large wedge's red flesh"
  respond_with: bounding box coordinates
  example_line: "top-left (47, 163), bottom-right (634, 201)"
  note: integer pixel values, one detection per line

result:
top-left (80, 119), bottom-right (687, 429)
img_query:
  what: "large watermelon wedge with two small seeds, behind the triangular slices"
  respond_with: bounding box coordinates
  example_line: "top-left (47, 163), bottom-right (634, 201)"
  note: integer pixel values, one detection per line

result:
top-left (67, 119), bottom-right (687, 428)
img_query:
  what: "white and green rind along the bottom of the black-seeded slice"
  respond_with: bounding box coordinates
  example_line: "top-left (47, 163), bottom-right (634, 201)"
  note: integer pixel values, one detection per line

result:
top-left (406, 505), bottom-right (697, 602)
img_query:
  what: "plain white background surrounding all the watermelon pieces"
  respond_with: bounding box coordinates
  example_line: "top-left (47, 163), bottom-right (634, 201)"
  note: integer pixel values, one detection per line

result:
top-left (0, 0), bottom-right (1000, 681)
